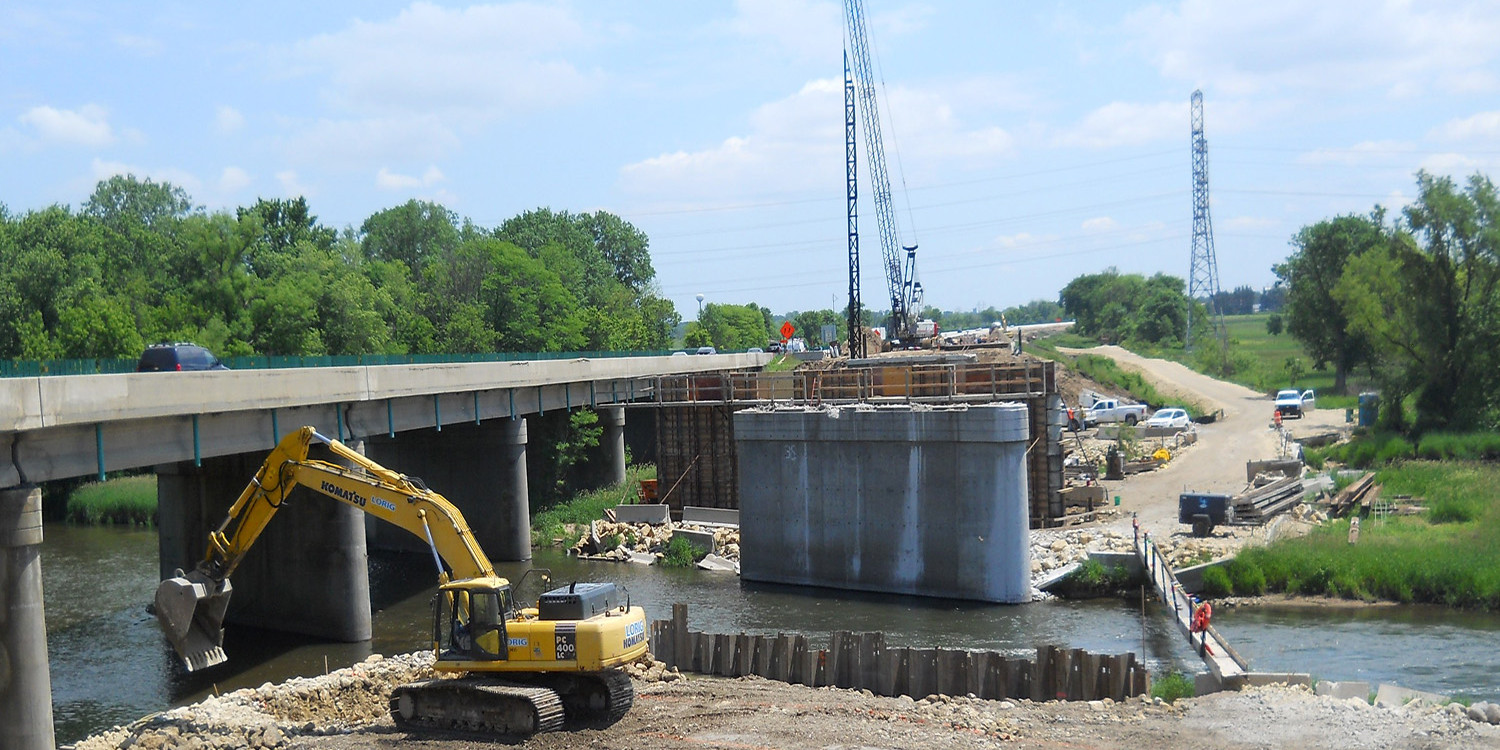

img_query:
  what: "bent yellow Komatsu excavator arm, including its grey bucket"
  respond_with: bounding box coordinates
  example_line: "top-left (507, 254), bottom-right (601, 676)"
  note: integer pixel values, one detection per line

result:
top-left (156, 428), bottom-right (495, 672)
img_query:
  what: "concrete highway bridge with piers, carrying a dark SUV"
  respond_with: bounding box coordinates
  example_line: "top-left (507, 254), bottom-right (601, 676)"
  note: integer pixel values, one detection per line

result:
top-left (0, 354), bottom-right (771, 750)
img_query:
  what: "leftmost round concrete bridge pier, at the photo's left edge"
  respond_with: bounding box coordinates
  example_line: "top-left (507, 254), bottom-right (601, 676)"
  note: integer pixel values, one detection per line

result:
top-left (0, 486), bottom-right (56, 750)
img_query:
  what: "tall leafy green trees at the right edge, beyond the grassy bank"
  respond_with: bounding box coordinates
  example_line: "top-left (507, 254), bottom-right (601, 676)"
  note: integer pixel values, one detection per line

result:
top-left (1274, 171), bottom-right (1500, 432)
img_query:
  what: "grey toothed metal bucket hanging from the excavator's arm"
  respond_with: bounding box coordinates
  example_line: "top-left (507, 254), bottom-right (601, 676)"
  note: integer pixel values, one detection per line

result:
top-left (156, 569), bottom-right (233, 672)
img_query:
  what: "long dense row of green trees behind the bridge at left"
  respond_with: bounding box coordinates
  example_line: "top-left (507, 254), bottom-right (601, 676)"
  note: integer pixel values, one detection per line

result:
top-left (0, 176), bottom-right (681, 360)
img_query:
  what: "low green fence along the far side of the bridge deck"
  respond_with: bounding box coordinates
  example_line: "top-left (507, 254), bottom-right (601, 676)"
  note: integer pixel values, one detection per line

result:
top-left (0, 350), bottom-right (672, 378)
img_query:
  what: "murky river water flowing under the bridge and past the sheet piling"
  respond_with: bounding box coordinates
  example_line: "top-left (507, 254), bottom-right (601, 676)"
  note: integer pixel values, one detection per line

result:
top-left (42, 525), bottom-right (1500, 744)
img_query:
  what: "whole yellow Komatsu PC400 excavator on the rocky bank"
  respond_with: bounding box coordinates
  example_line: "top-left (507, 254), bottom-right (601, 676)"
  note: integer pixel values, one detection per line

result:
top-left (156, 428), bottom-right (647, 740)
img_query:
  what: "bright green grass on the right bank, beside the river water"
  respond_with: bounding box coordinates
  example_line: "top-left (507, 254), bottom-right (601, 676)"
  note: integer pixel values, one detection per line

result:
top-left (1232, 461), bottom-right (1500, 611)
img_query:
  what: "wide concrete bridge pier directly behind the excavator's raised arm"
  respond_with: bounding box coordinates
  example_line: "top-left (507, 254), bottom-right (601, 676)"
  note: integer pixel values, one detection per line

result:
top-left (156, 441), bottom-right (372, 642)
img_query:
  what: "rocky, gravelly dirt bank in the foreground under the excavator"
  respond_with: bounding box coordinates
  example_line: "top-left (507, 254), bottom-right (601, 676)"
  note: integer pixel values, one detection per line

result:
top-left (74, 654), bottom-right (1500, 750)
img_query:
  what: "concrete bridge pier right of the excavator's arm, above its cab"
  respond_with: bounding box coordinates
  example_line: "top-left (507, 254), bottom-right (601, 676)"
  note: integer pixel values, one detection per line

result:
top-left (369, 419), bottom-right (534, 563)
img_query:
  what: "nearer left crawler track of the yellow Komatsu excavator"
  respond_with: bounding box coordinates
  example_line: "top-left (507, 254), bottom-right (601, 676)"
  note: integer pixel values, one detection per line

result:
top-left (390, 678), bottom-right (566, 741)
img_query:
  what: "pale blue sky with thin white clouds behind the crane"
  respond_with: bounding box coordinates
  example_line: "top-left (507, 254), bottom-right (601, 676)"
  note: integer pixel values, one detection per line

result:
top-left (0, 0), bottom-right (1500, 320)
